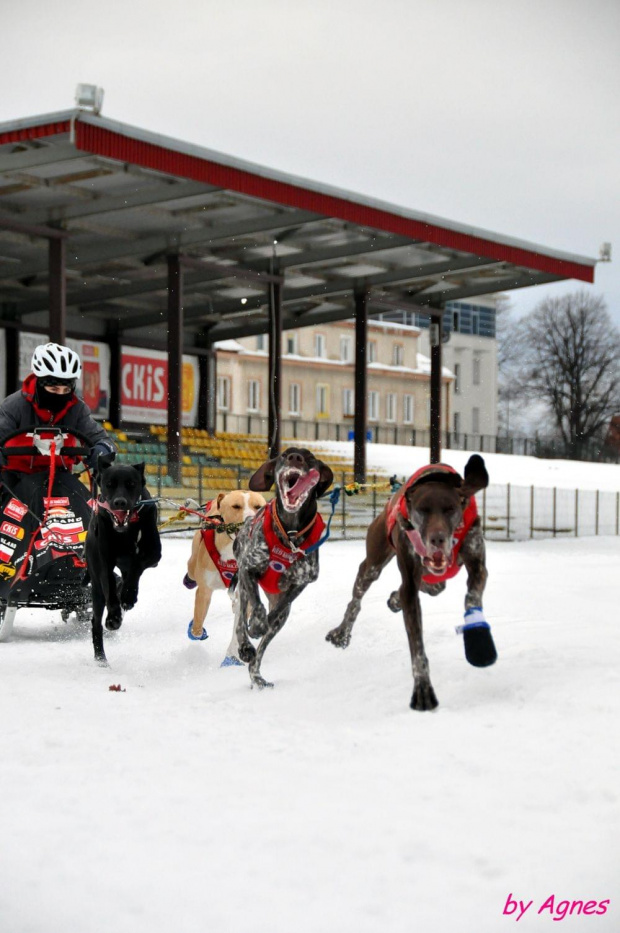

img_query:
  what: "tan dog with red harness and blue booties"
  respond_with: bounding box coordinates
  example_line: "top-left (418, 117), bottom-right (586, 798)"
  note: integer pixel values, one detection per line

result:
top-left (183, 489), bottom-right (265, 667)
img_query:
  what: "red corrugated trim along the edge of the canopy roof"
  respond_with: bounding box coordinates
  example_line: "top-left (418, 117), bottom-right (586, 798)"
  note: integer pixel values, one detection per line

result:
top-left (0, 120), bottom-right (594, 282)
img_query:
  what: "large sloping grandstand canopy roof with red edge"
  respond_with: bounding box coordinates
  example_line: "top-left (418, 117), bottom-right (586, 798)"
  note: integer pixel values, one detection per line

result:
top-left (0, 110), bottom-right (595, 348)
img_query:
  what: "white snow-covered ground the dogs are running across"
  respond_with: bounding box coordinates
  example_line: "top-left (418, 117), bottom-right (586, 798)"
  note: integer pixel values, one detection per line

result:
top-left (0, 532), bottom-right (620, 933)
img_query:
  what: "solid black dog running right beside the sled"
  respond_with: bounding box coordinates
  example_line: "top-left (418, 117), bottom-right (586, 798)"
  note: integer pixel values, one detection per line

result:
top-left (86, 454), bottom-right (161, 664)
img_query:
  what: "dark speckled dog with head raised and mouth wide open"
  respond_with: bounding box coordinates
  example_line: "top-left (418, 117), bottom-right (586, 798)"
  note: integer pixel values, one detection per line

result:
top-left (234, 447), bottom-right (334, 688)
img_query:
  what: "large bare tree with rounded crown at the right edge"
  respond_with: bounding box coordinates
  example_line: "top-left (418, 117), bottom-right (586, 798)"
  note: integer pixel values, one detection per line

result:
top-left (519, 290), bottom-right (620, 457)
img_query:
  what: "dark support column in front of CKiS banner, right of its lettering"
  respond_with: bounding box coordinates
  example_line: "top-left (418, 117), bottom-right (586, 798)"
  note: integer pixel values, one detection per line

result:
top-left (168, 255), bottom-right (183, 483)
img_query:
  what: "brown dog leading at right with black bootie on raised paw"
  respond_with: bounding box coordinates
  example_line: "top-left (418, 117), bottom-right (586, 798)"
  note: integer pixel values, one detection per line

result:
top-left (326, 454), bottom-right (497, 710)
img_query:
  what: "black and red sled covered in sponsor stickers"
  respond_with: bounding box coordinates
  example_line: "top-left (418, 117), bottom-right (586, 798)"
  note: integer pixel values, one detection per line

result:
top-left (0, 425), bottom-right (91, 641)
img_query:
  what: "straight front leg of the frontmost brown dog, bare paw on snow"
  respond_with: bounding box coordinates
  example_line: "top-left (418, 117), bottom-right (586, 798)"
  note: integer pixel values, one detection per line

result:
top-left (396, 538), bottom-right (438, 711)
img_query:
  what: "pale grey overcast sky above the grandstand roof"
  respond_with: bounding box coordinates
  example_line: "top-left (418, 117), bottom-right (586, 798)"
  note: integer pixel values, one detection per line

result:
top-left (0, 0), bottom-right (620, 326)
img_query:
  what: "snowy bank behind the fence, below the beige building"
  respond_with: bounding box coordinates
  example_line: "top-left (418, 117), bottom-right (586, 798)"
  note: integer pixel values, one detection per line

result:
top-left (303, 441), bottom-right (620, 492)
